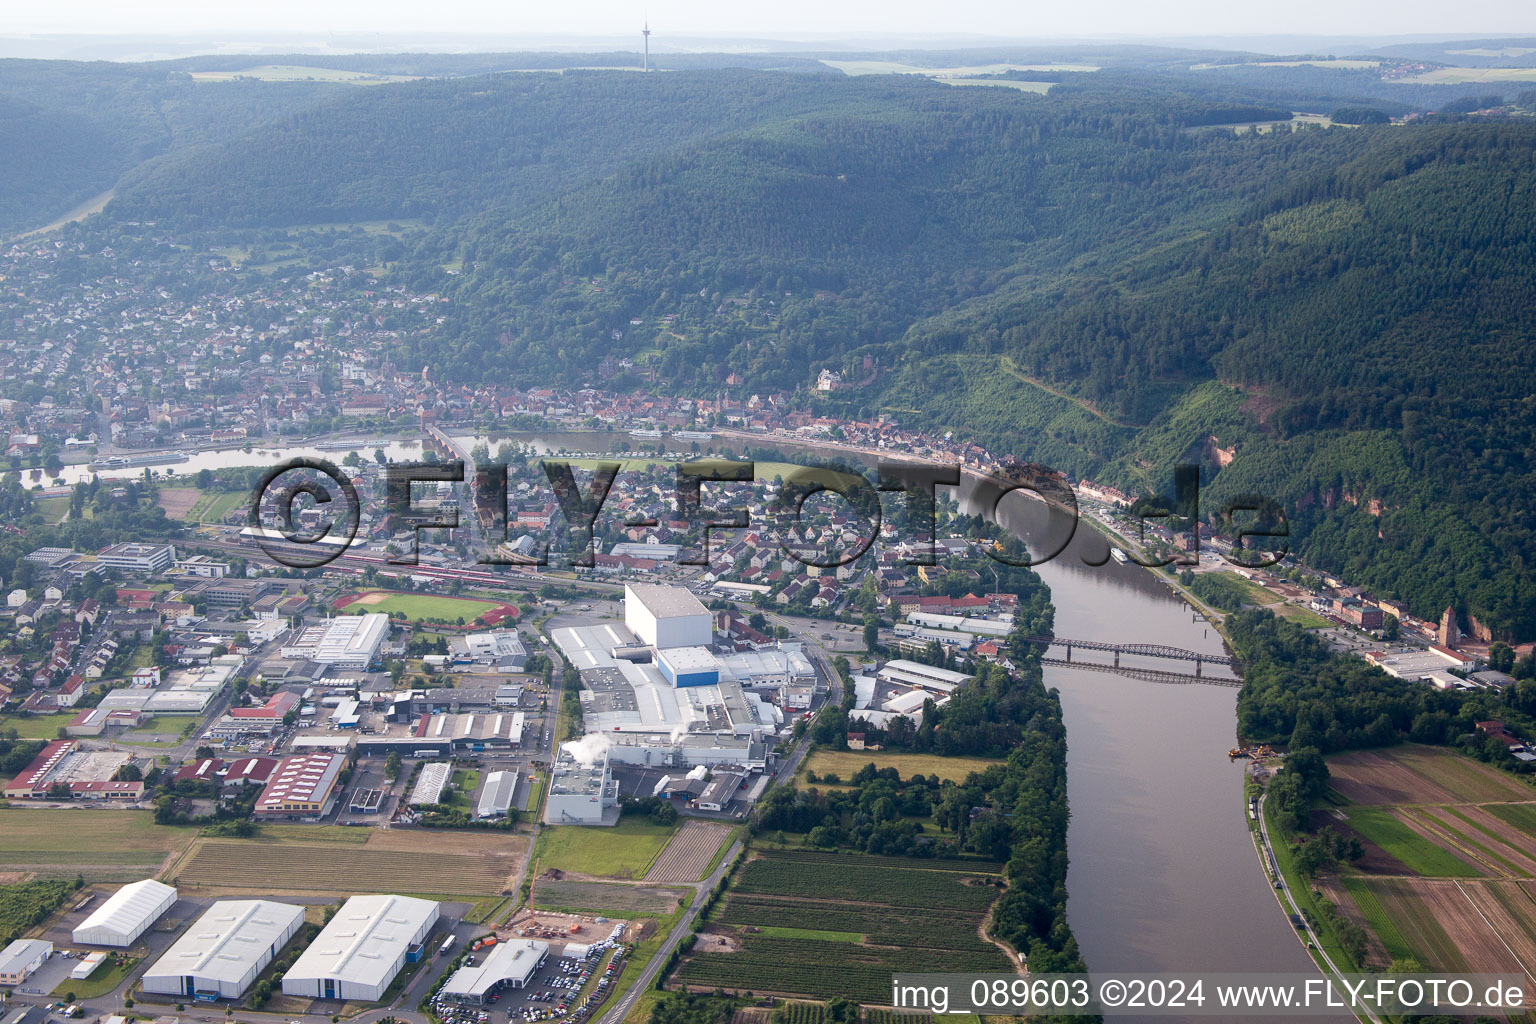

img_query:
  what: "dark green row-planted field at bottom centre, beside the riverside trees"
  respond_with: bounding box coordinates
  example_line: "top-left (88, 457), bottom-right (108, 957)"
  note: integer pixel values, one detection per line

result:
top-left (673, 852), bottom-right (1015, 1004)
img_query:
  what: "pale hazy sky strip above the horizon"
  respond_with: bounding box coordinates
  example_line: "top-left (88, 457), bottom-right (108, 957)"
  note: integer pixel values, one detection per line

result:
top-left (9, 0), bottom-right (1536, 46)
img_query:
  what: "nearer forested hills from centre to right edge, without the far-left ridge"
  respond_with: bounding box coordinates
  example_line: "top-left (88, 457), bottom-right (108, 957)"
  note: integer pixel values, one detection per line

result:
top-left (390, 81), bottom-right (1536, 636)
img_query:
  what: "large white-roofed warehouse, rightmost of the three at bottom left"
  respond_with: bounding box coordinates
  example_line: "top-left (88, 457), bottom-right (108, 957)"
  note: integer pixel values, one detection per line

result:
top-left (283, 897), bottom-right (438, 1003)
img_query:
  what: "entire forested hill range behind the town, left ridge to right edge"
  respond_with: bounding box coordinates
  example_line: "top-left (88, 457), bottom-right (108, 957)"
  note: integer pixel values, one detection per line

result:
top-left (29, 66), bottom-right (1536, 637)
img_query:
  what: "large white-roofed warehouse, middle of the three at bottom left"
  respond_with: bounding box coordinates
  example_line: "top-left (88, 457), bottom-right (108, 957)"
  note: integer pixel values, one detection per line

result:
top-left (143, 900), bottom-right (304, 1003)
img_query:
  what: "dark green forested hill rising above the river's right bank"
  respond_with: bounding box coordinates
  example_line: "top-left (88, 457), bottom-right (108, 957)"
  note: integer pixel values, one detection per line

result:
top-left (888, 123), bottom-right (1536, 637)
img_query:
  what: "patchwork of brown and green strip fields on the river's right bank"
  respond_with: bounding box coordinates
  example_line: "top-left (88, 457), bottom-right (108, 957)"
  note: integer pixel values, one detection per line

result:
top-left (1329, 746), bottom-right (1536, 981)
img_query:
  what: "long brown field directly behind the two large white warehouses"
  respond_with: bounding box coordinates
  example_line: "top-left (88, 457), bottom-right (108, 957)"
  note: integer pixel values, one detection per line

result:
top-left (166, 829), bottom-right (527, 897)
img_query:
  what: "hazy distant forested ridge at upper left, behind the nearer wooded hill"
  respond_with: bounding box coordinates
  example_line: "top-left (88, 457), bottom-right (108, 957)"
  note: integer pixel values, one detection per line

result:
top-left (112, 71), bottom-right (940, 227)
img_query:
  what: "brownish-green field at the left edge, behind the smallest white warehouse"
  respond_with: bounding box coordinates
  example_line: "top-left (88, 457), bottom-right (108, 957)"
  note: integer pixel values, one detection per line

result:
top-left (0, 808), bottom-right (197, 881)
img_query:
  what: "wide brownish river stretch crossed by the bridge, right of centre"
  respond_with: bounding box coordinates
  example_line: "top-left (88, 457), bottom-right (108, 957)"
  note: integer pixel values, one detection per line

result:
top-left (965, 478), bottom-right (1350, 1021)
